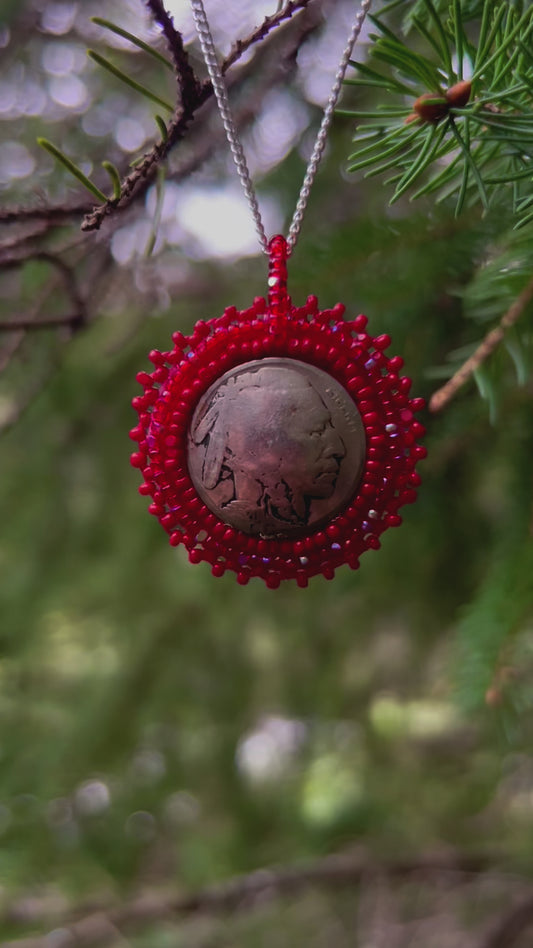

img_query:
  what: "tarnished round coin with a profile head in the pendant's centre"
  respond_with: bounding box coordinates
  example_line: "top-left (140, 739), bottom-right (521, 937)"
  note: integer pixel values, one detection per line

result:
top-left (188, 358), bottom-right (366, 537)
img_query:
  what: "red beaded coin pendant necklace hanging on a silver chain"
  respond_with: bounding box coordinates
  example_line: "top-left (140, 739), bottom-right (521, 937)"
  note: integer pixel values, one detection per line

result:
top-left (130, 0), bottom-right (426, 588)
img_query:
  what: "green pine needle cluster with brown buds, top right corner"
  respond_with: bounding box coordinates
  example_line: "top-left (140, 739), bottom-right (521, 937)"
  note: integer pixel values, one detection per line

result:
top-left (340, 0), bottom-right (533, 214)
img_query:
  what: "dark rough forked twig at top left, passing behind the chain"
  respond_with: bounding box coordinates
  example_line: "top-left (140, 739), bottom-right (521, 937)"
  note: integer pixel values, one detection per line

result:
top-left (81, 0), bottom-right (318, 231)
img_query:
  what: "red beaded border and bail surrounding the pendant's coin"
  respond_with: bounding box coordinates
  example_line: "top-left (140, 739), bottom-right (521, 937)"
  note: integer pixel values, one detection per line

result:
top-left (130, 236), bottom-right (426, 589)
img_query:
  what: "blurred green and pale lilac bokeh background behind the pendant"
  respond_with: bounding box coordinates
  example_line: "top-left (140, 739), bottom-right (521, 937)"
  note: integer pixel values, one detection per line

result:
top-left (0, 0), bottom-right (533, 948)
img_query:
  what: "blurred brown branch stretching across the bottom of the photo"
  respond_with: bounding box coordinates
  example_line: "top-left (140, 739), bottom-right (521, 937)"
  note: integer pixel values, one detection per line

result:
top-left (0, 853), bottom-right (494, 948)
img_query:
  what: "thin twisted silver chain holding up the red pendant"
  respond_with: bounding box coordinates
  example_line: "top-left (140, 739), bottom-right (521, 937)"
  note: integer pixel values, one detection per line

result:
top-left (191, 0), bottom-right (372, 253)
